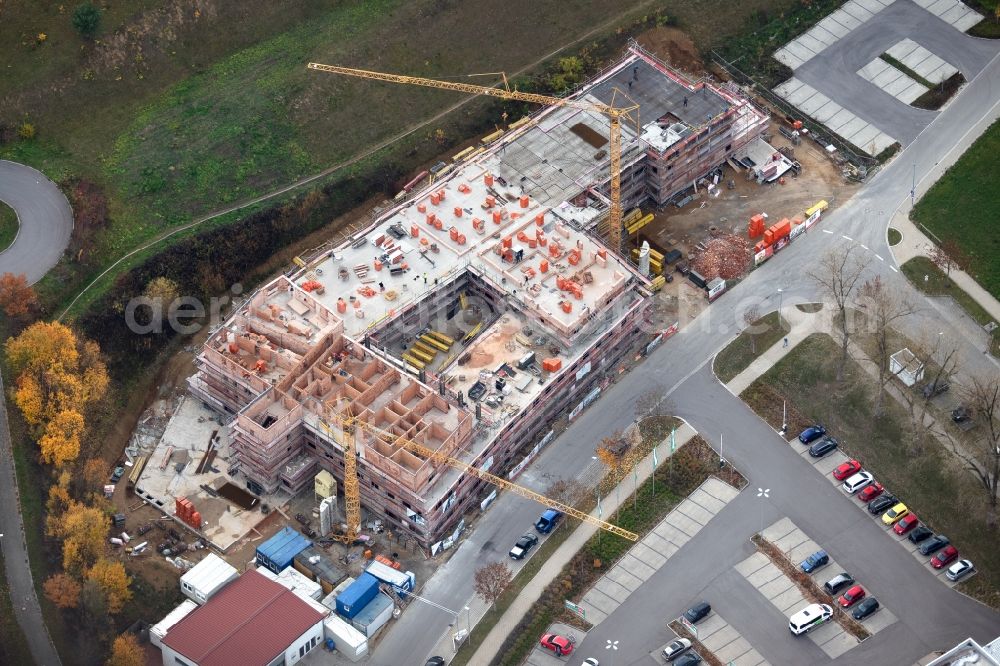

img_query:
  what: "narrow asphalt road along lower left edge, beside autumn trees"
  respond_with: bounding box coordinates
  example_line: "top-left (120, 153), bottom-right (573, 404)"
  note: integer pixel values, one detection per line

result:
top-left (0, 370), bottom-right (61, 666)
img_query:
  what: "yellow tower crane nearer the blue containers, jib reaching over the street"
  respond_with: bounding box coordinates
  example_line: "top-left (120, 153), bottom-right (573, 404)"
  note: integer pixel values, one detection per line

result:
top-left (320, 417), bottom-right (639, 543)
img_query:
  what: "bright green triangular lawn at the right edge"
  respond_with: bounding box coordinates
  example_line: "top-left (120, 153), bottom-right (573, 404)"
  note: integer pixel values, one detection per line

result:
top-left (910, 116), bottom-right (1000, 298)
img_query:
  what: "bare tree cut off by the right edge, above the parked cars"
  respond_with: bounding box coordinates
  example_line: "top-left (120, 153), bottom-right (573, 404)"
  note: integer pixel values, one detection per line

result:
top-left (954, 374), bottom-right (1000, 528)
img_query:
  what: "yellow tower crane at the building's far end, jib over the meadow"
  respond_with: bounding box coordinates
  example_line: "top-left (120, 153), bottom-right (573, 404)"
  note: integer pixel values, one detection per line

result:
top-left (308, 62), bottom-right (639, 253)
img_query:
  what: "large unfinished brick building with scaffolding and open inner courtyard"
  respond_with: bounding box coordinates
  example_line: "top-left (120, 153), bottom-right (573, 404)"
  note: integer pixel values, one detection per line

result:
top-left (189, 46), bottom-right (767, 546)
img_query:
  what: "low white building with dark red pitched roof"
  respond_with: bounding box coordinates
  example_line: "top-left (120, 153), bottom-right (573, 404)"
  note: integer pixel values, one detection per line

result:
top-left (162, 570), bottom-right (324, 666)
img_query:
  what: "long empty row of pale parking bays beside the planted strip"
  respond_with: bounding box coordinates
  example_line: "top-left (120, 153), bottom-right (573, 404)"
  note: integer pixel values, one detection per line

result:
top-left (580, 477), bottom-right (739, 625)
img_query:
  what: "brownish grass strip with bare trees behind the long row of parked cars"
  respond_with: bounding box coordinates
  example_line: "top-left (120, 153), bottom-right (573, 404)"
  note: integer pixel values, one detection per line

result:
top-left (741, 334), bottom-right (1000, 608)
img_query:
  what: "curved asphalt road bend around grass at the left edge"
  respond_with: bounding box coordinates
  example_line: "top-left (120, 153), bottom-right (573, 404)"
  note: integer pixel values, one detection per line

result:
top-left (0, 160), bottom-right (73, 284)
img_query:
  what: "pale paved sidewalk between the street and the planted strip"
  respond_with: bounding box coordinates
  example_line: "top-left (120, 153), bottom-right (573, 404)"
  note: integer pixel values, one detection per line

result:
top-left (469, 423), bottom-right (698, 664)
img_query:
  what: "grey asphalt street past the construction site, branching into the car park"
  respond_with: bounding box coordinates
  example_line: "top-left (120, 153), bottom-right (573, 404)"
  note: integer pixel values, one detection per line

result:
top-left (372, 35), bottom-right (1000, 666)
